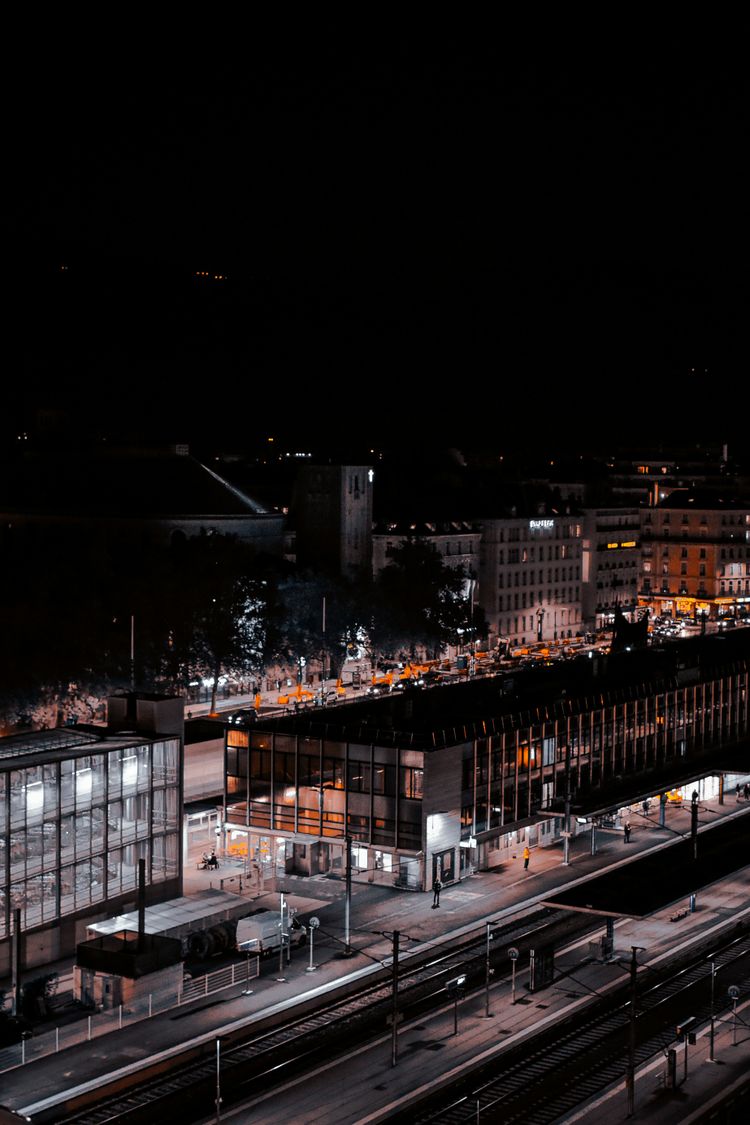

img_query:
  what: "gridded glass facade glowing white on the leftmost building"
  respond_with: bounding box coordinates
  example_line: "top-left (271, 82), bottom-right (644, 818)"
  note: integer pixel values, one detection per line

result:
top-left (0, 736), bottom-right (181, 938)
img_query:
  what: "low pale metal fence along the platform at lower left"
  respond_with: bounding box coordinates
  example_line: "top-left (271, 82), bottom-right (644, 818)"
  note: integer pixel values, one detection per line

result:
top-left (0, 955), bottom-right (260, 1072)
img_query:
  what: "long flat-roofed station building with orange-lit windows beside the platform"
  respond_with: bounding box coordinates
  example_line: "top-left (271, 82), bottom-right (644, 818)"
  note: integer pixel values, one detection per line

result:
top-left (224, 630), bottom-right (750, 890)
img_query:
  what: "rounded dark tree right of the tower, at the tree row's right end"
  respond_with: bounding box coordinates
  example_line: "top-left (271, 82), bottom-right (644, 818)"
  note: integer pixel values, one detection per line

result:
top-left (370, 537), bottom-right (469, 658)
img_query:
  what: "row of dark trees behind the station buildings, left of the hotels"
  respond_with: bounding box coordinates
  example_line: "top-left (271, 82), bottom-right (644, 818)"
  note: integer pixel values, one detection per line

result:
top-left (0, 531), bottom-right (481, 728)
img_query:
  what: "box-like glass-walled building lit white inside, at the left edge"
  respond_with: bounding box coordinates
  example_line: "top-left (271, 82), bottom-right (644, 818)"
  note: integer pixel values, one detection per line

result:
top-left (0, 694), bottom-right (183, 975)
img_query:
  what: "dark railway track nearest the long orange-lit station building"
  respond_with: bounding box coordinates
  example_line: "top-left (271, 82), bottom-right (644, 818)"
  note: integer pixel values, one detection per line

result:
top-left (27, 908), bottom-right (600, 1125)
